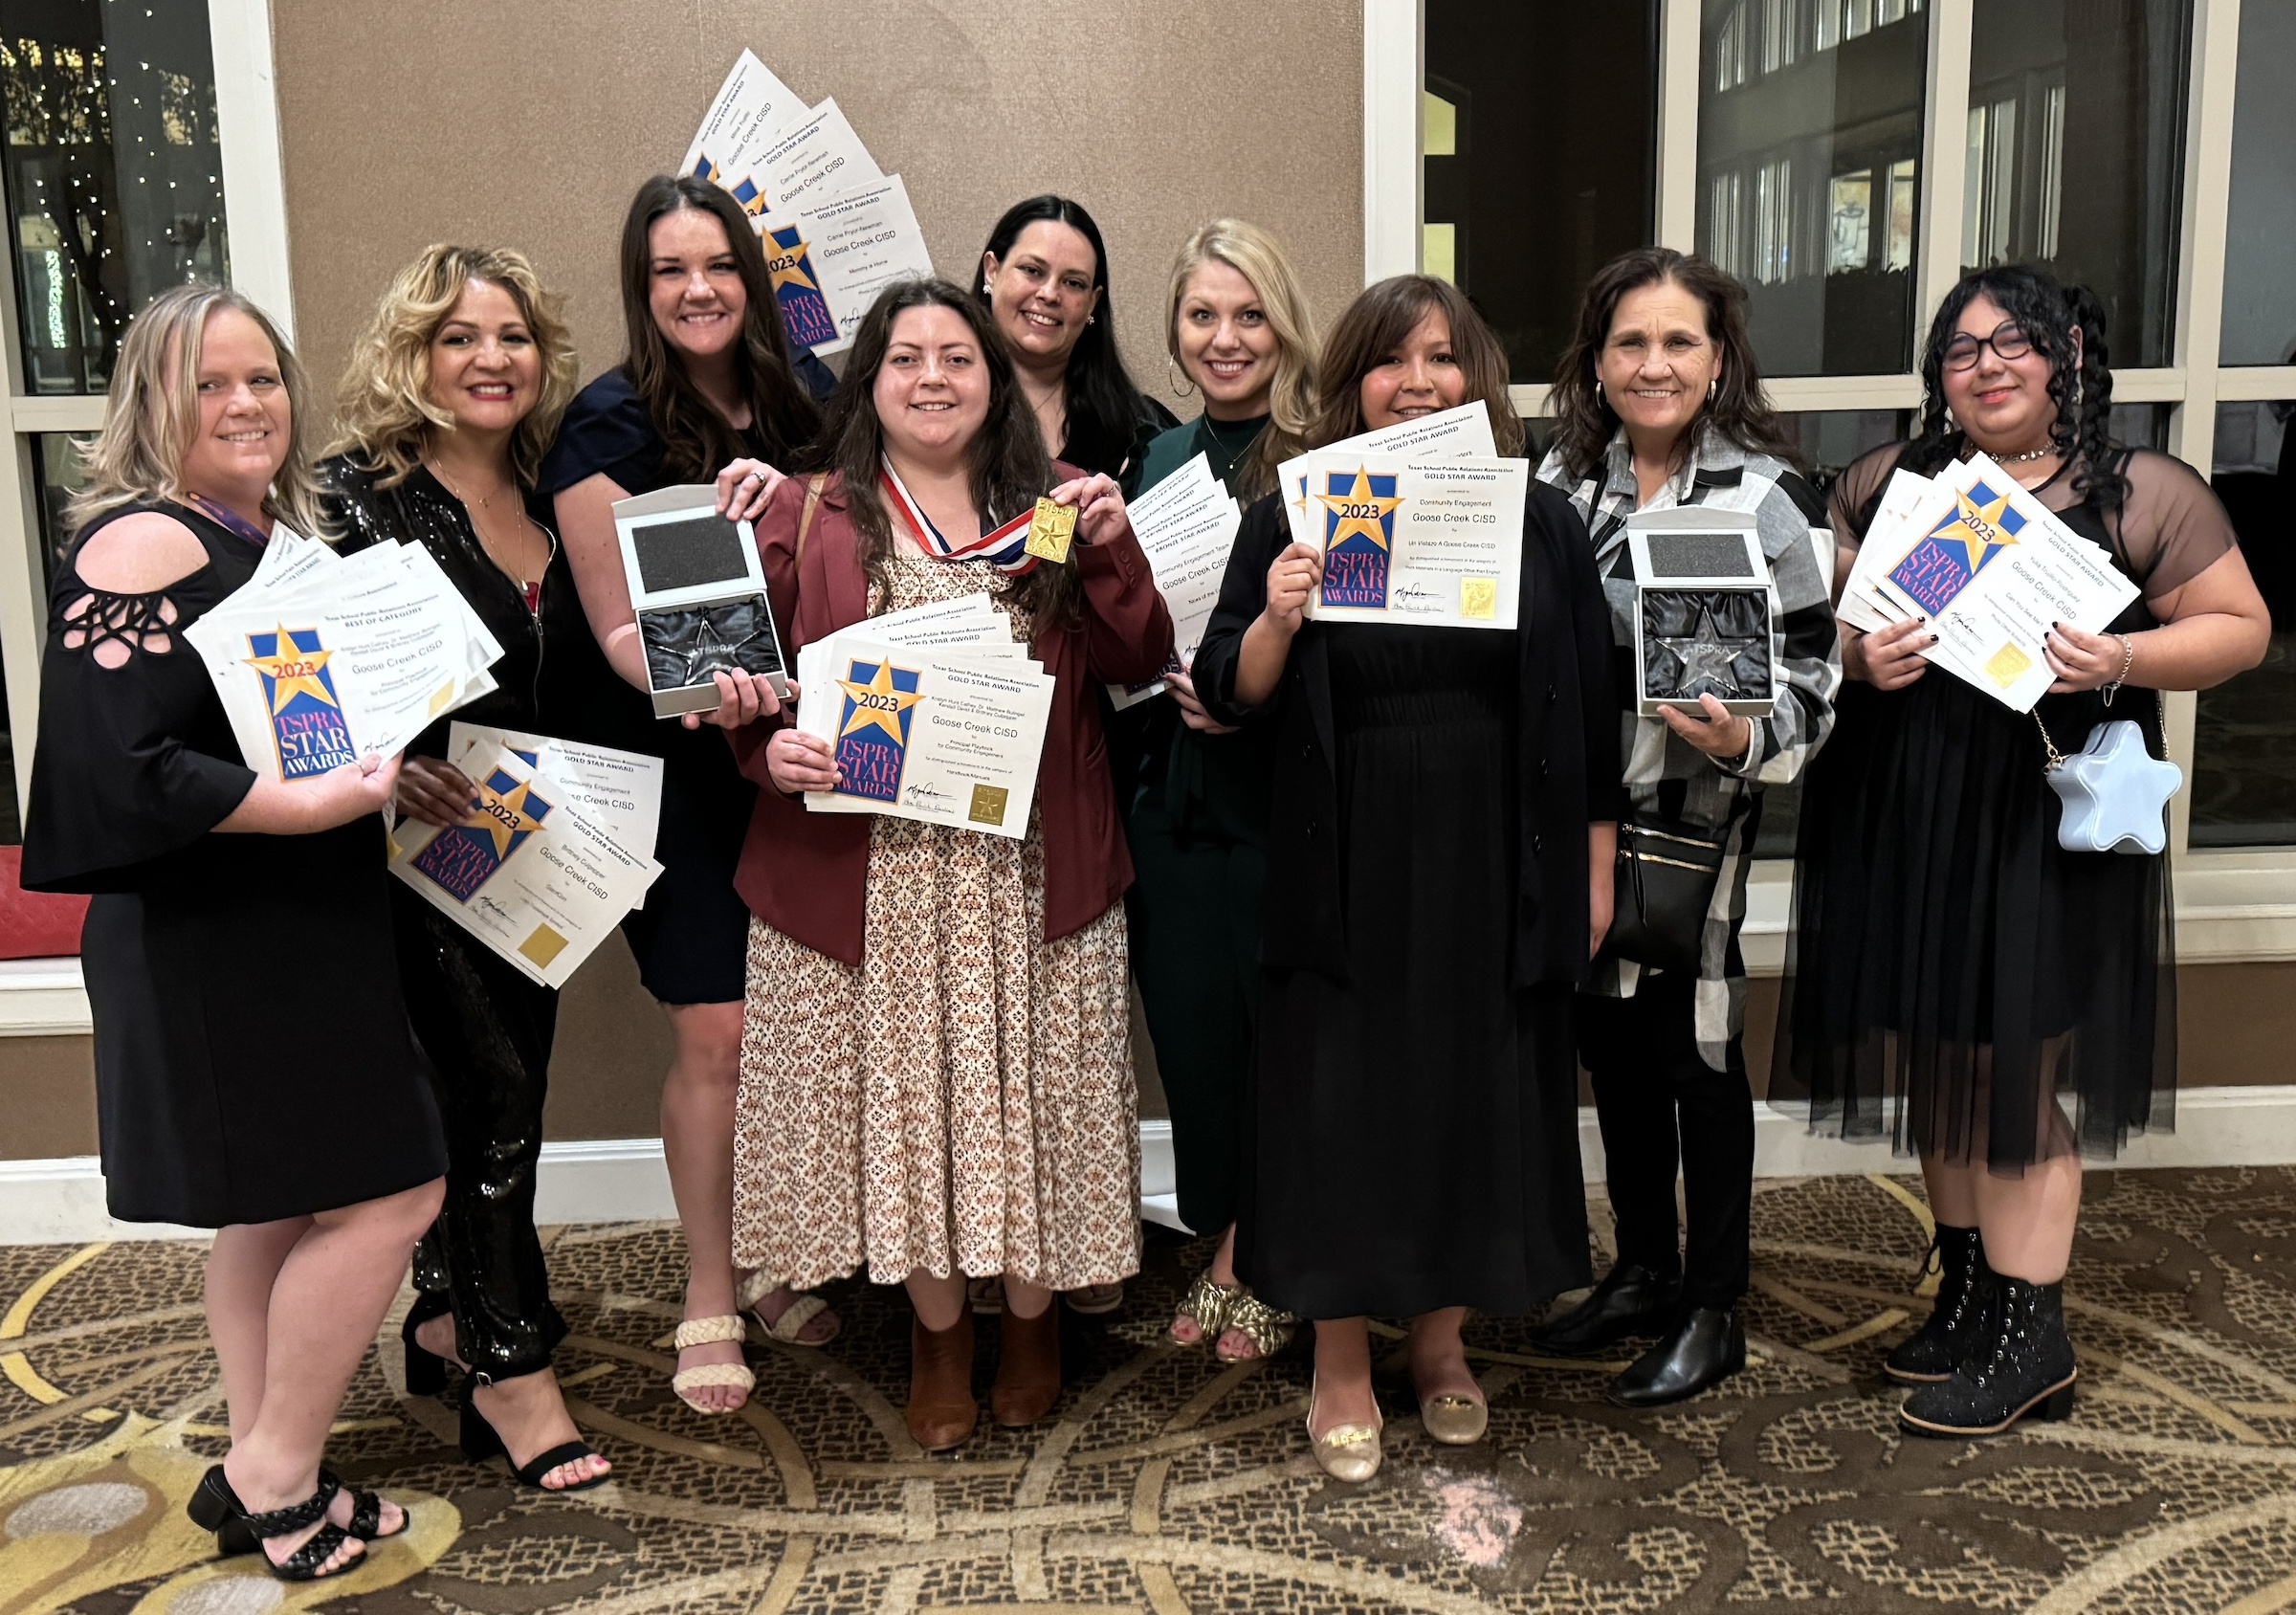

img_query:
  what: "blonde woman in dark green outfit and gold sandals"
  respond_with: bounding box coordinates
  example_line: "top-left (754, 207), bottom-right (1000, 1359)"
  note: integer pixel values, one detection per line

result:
top-left (1109, 218), bottom-right (1315, 1362)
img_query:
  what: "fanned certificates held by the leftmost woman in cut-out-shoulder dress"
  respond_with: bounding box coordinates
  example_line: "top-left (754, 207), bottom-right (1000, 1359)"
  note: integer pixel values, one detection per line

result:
top-left (184, 528), bottom-right (503, 781)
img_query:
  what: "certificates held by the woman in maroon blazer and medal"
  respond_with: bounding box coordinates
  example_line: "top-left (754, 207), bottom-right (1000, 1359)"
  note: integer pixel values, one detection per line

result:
top-left (797, 595), bottom-right (1056, 841)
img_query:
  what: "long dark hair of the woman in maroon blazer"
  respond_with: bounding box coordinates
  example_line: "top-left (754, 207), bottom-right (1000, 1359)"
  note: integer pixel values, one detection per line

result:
top-left (813, 278), bottom-right (1084, 623)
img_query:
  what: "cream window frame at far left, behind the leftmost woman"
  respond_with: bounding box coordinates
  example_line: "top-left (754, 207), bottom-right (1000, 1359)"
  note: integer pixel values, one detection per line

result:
top-left (0, 0), bottom-right (294, 836)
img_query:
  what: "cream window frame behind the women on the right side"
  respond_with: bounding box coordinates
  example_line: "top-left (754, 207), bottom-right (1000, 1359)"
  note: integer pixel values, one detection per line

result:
top-left (1364, 0), bottom-right (2296, 974)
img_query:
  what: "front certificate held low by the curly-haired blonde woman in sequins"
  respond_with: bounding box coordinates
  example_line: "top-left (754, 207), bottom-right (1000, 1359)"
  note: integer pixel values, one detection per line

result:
top-left (390, 744), bottom-right (661, 987)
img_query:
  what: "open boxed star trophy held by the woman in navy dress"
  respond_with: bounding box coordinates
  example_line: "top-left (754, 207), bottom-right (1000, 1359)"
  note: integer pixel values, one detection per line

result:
top-left (613, 482), bottom-right (790, 717)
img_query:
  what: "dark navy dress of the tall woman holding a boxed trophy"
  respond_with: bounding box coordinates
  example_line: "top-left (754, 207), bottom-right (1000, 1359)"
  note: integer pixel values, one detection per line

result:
top-left (538, 371), bottom-right (789, 1004)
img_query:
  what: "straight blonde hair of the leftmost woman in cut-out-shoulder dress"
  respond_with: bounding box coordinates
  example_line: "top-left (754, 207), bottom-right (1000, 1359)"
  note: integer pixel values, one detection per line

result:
top-left (64, 280), bottom-right (328, 538)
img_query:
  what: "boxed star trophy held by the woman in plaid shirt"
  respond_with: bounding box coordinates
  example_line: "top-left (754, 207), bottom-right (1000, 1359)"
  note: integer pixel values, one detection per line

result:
top-left (1625, 505), bottom-right (1775, 717)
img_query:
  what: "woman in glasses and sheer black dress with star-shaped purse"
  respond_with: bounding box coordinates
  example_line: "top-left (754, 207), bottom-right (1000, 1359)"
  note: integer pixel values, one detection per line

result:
top-left (1770, 267), bottom-right (2268, 1436)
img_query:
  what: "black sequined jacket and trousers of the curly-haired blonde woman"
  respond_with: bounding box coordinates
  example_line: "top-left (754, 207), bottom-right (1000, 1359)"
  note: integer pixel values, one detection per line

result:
top-left (321, 459), bottom-right (620, 1379)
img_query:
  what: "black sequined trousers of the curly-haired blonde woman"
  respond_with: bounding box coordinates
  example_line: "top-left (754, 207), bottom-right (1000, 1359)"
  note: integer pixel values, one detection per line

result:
top-left (390, 880), bottom-right (567, 1381)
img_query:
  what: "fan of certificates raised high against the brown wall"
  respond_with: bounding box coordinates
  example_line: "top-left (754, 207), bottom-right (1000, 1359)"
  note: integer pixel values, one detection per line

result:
top-left (679, 51), bottom-right (932, 354)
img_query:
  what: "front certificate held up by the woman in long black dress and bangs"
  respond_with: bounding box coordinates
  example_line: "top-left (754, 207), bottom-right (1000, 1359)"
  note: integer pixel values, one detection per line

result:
top-left (1302, 448), bottom-right (1532, 628)
